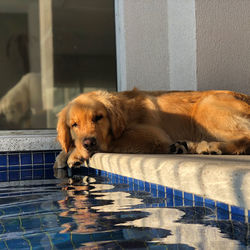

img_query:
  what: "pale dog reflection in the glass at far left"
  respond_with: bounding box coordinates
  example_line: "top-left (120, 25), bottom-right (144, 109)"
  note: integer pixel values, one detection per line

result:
top-left (0, 73), bottom-right (42, 128)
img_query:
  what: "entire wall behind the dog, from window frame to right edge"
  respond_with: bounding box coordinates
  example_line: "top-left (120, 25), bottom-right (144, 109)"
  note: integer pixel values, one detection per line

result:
top-left (115, 0), bottom-right (250, 93)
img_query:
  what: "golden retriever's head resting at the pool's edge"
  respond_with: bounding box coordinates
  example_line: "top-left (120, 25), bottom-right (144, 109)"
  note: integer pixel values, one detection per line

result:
top-left (57, 91), bottom-right (125, 159)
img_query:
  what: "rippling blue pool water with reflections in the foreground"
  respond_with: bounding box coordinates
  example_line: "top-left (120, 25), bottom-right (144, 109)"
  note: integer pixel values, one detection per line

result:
top-left (0, 168), bottom-right (250, 250)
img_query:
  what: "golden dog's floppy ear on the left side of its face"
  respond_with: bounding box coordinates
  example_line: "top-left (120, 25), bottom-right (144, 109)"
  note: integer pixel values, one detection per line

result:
top-left (57, 107), bottom-right (73, 153)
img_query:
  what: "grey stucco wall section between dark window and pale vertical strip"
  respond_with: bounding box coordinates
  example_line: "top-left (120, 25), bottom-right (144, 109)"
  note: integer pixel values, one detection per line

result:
top-left (115, 0), bottom-right (169, 90)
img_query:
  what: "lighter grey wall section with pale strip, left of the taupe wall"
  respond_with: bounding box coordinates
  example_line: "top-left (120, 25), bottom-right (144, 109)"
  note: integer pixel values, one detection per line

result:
top-left (115, 0), bottom-right (196, 90)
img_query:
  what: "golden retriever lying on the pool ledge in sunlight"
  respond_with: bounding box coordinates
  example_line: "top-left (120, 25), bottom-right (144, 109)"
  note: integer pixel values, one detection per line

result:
top-left (56, 89), bottom-right (250, 167)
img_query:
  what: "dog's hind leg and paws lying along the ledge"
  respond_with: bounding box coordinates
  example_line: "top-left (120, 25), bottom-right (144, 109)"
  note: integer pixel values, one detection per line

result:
top-left (171, 137), bottom-right (250, 155)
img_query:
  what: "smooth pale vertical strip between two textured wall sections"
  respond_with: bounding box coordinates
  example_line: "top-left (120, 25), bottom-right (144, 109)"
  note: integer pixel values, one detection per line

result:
top-left (166, 0), bottom-right (197, 90)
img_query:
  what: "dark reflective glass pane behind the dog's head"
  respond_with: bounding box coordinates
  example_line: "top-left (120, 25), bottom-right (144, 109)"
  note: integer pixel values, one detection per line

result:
top-left (0, 0), bottom-right (117, 130)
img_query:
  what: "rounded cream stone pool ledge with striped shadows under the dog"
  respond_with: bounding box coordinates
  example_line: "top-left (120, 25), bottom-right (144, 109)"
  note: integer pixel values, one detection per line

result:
top-left (90, 153), bottom-right (250, 210)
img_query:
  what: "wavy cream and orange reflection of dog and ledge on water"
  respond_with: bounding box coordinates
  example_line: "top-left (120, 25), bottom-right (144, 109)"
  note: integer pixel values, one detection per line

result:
top-left (53, 167), bottom-right (249, 249)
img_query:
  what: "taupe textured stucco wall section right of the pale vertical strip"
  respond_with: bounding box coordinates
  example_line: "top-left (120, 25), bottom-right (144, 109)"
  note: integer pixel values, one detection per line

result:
top-left (196, 0), bottom-right (250, 94)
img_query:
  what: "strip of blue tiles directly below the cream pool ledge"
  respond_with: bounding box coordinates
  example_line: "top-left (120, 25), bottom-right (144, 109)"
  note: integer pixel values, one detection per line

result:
top-left (87, 167), bottom-right (250, 224)
